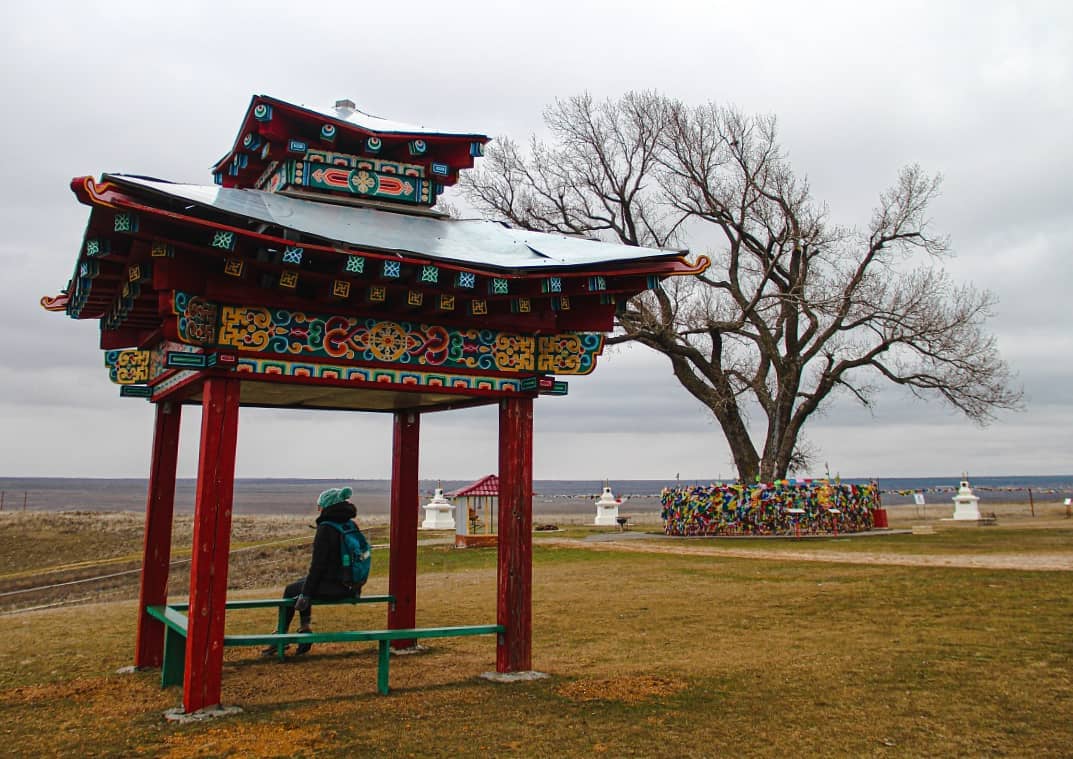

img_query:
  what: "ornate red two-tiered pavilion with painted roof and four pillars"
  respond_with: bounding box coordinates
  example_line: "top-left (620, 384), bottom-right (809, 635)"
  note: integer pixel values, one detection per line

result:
top-left (42, 96), bottom-right (707, 712)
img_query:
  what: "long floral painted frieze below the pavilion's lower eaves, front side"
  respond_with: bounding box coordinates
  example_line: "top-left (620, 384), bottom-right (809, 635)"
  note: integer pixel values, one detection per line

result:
top-left (173, 292), bottom-right (603, 375)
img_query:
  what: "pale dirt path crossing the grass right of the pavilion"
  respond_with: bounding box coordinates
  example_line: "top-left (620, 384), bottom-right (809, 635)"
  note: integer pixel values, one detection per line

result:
top-left (541, 538), bottom-right (1073, 572)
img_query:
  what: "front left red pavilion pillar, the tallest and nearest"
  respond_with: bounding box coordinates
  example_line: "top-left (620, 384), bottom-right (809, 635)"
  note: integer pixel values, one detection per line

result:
top-left (182, 377), bottom-right (239, 714)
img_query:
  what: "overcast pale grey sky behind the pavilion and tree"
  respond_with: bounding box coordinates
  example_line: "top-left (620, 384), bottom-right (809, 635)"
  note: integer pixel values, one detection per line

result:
top-left (0, 0), bottom-right (1073, 480)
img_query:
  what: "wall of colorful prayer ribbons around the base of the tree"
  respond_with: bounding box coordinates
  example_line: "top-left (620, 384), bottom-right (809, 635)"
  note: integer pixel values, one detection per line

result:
top-left (660, 480), bottom-right (882, 536)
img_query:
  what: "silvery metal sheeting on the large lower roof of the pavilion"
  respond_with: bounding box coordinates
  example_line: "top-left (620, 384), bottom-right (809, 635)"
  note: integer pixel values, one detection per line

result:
top-left (104, 174), bottom-right (682, 269)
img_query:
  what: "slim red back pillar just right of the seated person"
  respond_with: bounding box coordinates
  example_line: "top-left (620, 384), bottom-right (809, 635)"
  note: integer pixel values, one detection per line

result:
top-left (387, 411), bottom-right (421, 648)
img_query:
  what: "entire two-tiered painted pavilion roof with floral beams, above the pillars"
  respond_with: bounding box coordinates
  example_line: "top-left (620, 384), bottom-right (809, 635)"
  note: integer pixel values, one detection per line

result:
top-left (42, 96), bottom-right (708, 411)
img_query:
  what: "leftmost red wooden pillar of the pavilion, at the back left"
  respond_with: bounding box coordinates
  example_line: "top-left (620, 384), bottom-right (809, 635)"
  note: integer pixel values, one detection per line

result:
top-left (134, 403), bottom-right (182, 667)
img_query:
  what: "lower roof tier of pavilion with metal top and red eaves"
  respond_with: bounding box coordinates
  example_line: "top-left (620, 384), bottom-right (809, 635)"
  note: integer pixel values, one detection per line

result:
top-left (46, 175), bottom-right (707, 348)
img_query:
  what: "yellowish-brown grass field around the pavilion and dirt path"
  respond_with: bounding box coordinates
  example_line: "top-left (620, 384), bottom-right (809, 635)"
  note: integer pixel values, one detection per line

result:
top-left (0, 515), bottom-right (1073, 757)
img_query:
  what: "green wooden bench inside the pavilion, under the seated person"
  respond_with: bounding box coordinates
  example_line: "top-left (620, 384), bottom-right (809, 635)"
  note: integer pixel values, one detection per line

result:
top-left (146, 596), bottom-right (503, 696)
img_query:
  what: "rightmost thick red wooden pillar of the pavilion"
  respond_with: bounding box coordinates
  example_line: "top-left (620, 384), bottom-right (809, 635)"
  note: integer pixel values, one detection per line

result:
top-left (496, 398), bottom-right (533, 672)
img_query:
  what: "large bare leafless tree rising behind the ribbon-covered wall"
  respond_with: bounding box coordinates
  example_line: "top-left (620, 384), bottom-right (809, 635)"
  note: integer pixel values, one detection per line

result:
top-left (464, 92), bottom-right (1021, 481)
